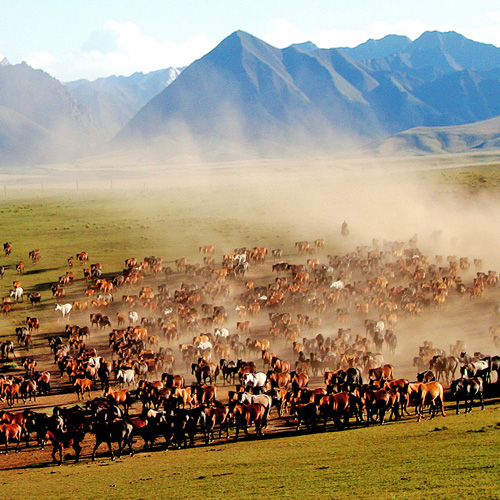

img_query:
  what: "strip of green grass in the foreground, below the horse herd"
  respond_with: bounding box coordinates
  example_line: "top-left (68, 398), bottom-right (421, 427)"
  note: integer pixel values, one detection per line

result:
top-left (0, 406), bottom-right (500, 500)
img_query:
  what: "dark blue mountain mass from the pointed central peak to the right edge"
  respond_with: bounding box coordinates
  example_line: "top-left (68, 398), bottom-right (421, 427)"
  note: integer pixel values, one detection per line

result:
top-left (117, 31), bottom-right (500, 158)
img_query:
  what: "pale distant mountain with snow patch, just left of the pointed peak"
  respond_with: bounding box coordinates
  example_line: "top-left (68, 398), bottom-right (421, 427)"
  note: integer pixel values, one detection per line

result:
top-left (65, 68), bottom-right (181, 135)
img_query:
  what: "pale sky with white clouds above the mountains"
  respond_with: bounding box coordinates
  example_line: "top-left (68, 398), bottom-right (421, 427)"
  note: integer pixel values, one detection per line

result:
top-left (0, 0), bottom-right (500, 82)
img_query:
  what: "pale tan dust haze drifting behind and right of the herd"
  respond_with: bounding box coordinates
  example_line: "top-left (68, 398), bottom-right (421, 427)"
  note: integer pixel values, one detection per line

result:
top-left (3, 127), bottom-right (500, 379)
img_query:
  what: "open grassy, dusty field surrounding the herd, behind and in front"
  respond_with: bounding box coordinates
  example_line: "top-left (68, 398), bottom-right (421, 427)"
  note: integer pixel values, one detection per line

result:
top-left (0, 154), bottom-right (500, 500)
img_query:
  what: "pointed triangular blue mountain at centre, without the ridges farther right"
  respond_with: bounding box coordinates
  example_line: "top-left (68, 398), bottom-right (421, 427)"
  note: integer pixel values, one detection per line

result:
top-left (117, 31), bottom-right (381, 154)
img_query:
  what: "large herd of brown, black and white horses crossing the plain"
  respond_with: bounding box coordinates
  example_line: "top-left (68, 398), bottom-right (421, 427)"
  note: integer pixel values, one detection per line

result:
top-left (0, 234), bottom-right (500, 463)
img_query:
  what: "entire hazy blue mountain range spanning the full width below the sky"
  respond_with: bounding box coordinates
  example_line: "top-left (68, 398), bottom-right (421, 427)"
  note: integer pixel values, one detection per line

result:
top-left (0, 31), bottom-right (500, 162)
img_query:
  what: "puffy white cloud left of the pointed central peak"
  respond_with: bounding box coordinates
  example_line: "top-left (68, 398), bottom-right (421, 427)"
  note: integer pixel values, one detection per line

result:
top-left (25, 20), bottom-right (216, 81)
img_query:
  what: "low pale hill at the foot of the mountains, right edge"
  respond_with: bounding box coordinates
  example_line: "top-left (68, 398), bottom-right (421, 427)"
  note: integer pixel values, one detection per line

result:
top-left (365, 116), bottom-right (500, 156)
